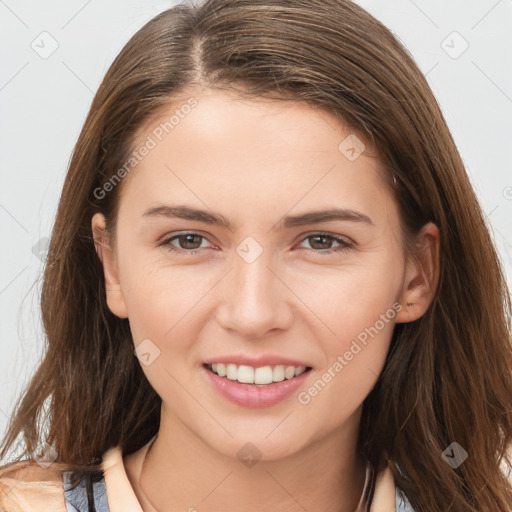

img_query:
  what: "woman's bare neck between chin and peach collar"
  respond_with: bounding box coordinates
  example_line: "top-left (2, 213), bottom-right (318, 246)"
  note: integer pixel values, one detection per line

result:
top-left (126, 409), bottom-right (366, 512)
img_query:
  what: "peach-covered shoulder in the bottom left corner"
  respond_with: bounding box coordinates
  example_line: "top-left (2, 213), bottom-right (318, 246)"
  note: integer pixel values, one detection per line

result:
top-left (0, 460), bottom-right (66, 512)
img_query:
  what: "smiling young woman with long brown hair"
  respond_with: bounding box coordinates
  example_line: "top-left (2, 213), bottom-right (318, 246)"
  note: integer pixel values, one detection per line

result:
top-left (0, 0), bottom-right (512, 512)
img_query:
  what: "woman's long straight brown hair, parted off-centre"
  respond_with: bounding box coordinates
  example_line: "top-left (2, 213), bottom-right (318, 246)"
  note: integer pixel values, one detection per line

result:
top-left (1, 0), bottom-right (512, 512)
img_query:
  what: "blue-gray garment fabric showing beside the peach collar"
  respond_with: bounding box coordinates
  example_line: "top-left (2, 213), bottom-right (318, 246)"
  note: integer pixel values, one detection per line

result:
top-left (62, 471), bottom-right (414, 512)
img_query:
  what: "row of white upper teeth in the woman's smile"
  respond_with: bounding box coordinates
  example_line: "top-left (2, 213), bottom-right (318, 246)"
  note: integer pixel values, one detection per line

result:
top-left (206, 363), bottom-right (306, 386)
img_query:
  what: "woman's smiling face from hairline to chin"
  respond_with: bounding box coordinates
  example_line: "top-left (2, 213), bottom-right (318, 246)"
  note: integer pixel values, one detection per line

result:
top-left (93, 91), bottom-right (436, 459)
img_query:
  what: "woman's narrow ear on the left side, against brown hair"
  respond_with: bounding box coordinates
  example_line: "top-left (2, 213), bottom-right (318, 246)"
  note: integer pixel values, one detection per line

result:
top-left (91, 213), bottom-right (128, 318)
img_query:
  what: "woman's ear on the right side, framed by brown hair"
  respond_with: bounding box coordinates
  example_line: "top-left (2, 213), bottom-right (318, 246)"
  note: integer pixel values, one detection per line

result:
top-left (396, 222), bottom-right (440, 323)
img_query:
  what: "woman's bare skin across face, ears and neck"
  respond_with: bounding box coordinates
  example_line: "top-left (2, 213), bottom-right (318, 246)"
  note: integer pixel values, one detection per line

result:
top-left (92, 90), bottom-right (439, 512)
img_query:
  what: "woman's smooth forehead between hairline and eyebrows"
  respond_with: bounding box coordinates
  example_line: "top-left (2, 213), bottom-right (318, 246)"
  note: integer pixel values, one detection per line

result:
top-left (117, 91), bottom-right (391, 228)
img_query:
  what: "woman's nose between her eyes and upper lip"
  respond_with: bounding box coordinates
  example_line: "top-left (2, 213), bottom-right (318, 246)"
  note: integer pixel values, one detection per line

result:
top-left (217, 251), bottom-right (293, 339)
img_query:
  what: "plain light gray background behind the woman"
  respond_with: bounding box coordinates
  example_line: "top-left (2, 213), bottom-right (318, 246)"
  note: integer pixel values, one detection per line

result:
top-left (0, 0), bottom-right (512, 448)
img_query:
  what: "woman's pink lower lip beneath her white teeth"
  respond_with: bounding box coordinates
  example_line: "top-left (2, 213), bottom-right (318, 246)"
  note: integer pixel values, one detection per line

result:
top-left (203, 366), bottom-right (311, 409)
